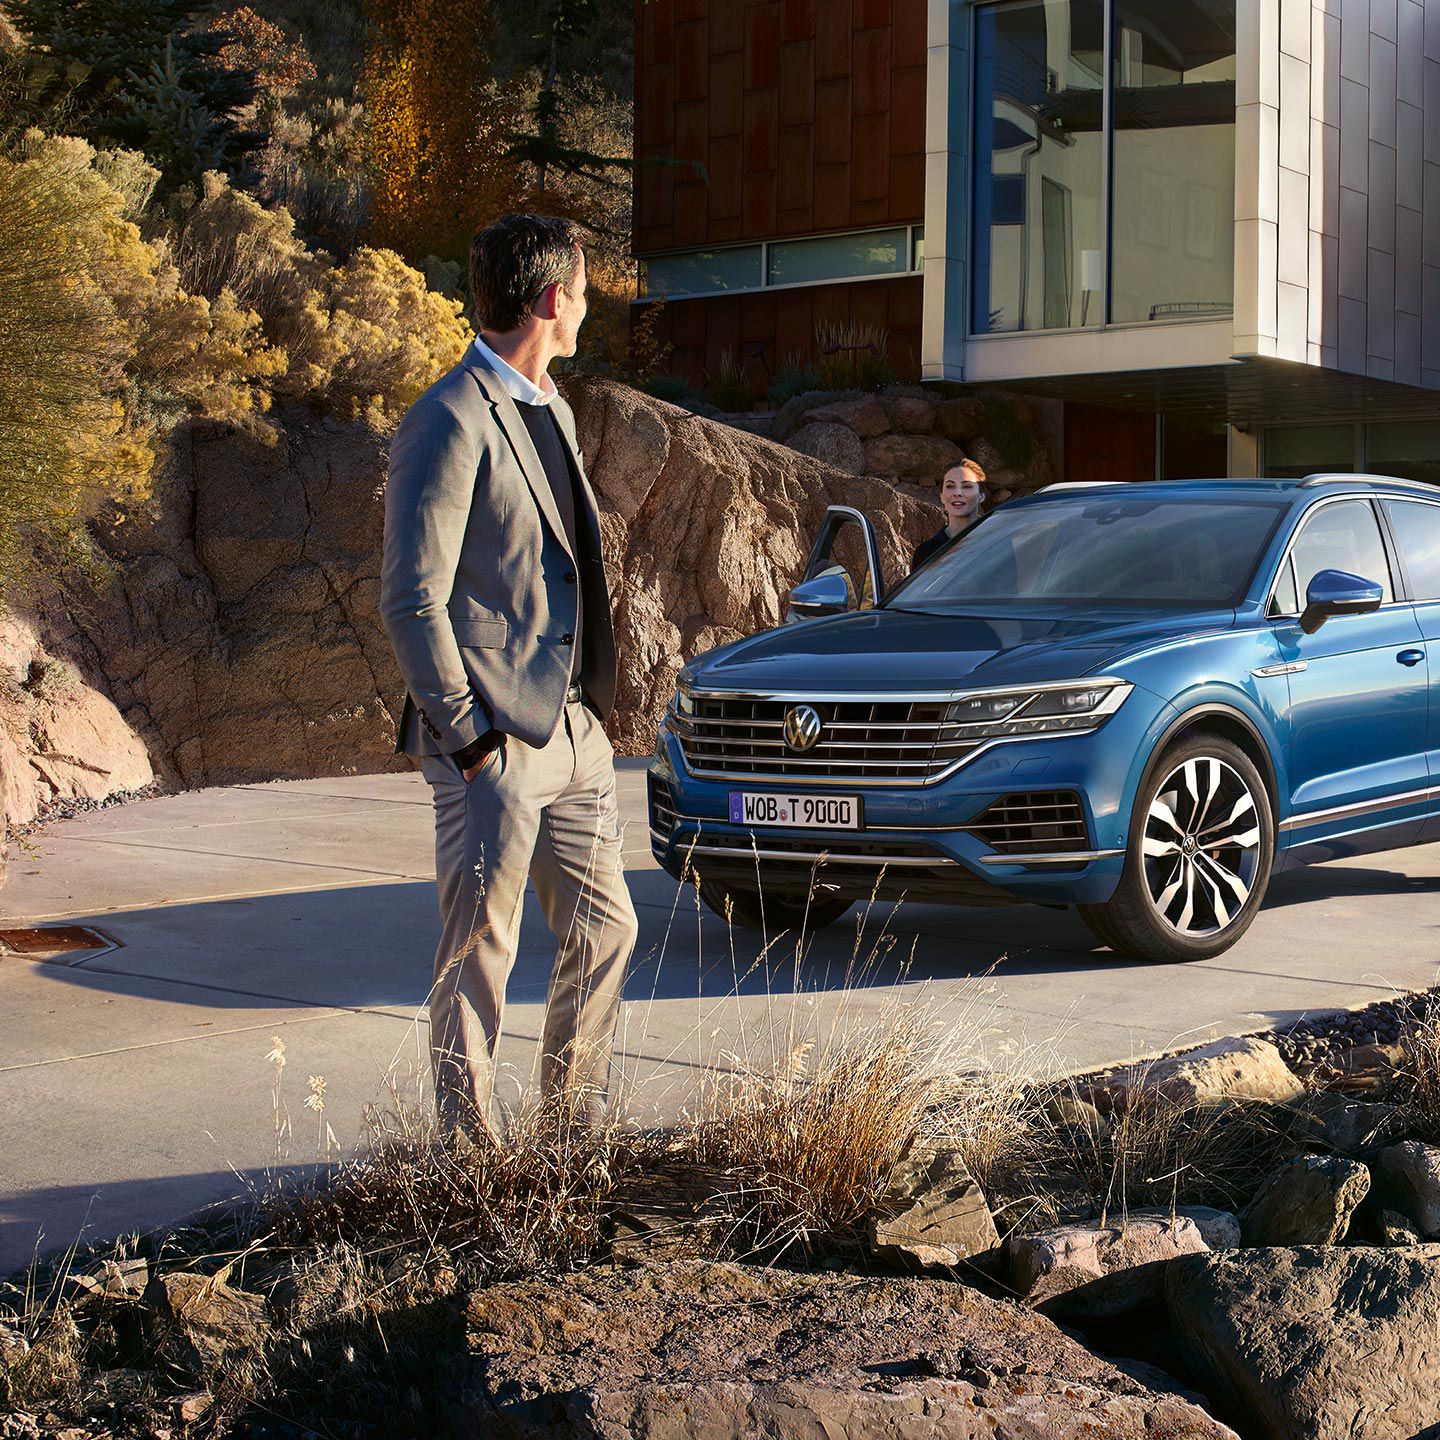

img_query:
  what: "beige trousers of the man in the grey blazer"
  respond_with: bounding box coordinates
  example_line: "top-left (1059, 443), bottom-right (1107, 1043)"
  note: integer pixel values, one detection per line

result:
top-left (420, 704), bottom-right (636, 1130)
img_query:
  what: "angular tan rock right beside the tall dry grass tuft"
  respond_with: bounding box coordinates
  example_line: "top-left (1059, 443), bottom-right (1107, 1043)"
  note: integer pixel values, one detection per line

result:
top-left (870, 1143), bottom-right (999, 1266)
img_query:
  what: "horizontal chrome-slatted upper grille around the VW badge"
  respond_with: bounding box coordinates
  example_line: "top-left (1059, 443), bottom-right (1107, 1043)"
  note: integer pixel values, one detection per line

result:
top-left (667, 694), bottom-right (978, 785)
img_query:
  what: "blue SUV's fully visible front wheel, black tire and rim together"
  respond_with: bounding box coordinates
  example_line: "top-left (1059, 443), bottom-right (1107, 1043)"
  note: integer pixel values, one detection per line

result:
top-left (1079, 734), bottom-right (1274, 963)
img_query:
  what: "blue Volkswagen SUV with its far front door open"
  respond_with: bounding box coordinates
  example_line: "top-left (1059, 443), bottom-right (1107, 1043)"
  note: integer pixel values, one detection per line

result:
top-left (648, 475), bottom-right (1440, 960)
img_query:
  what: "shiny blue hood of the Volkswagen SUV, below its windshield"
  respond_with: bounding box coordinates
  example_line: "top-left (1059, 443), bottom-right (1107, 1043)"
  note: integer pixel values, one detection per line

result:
top-left (683, 605), bottom-right (1236, 694)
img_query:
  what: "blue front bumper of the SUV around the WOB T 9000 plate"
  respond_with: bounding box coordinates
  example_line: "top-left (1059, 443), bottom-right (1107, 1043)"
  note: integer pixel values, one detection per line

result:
top-left (649, 691), bottom-right (1166, 904)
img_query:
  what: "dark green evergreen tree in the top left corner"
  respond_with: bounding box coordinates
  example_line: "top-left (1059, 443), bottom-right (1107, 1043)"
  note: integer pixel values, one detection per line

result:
top-left (6, 0), bottom-right (261, 187)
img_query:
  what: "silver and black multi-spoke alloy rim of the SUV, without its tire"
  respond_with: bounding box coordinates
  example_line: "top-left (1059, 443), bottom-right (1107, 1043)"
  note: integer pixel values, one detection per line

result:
top-left (1142, 756), bottom-right (1260, 939)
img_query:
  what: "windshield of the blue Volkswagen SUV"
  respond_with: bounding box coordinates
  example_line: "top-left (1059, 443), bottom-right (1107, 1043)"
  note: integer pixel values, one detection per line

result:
top-left (886, 491), bottom-right (1282, 611)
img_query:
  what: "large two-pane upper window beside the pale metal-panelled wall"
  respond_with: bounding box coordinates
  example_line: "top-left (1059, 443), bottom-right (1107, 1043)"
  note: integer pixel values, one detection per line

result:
top-left (971, 0), bottom-right (1236, 334)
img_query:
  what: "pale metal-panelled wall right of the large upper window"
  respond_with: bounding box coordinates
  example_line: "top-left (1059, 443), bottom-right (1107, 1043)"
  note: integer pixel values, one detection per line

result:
top-left (1236, 0), bottom-right (1440, 387)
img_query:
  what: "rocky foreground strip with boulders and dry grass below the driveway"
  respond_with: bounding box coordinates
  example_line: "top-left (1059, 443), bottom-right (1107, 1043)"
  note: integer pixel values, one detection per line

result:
top-left (8, 998), bottom-right (1440, 1440)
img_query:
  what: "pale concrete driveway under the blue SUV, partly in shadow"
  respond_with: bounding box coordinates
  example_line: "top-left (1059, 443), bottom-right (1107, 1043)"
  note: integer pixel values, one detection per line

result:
top-left (0, 760), bottom-right (1440, 1273)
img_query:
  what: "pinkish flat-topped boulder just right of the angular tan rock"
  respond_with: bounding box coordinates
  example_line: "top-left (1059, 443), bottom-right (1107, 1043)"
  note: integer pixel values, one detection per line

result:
top-left (1005, 1212), bottom-right (1205, 1318)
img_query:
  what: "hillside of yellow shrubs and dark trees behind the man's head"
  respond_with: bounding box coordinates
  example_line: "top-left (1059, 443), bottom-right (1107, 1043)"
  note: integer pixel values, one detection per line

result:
top-left (0, 0), bottom-right (634, 593)
